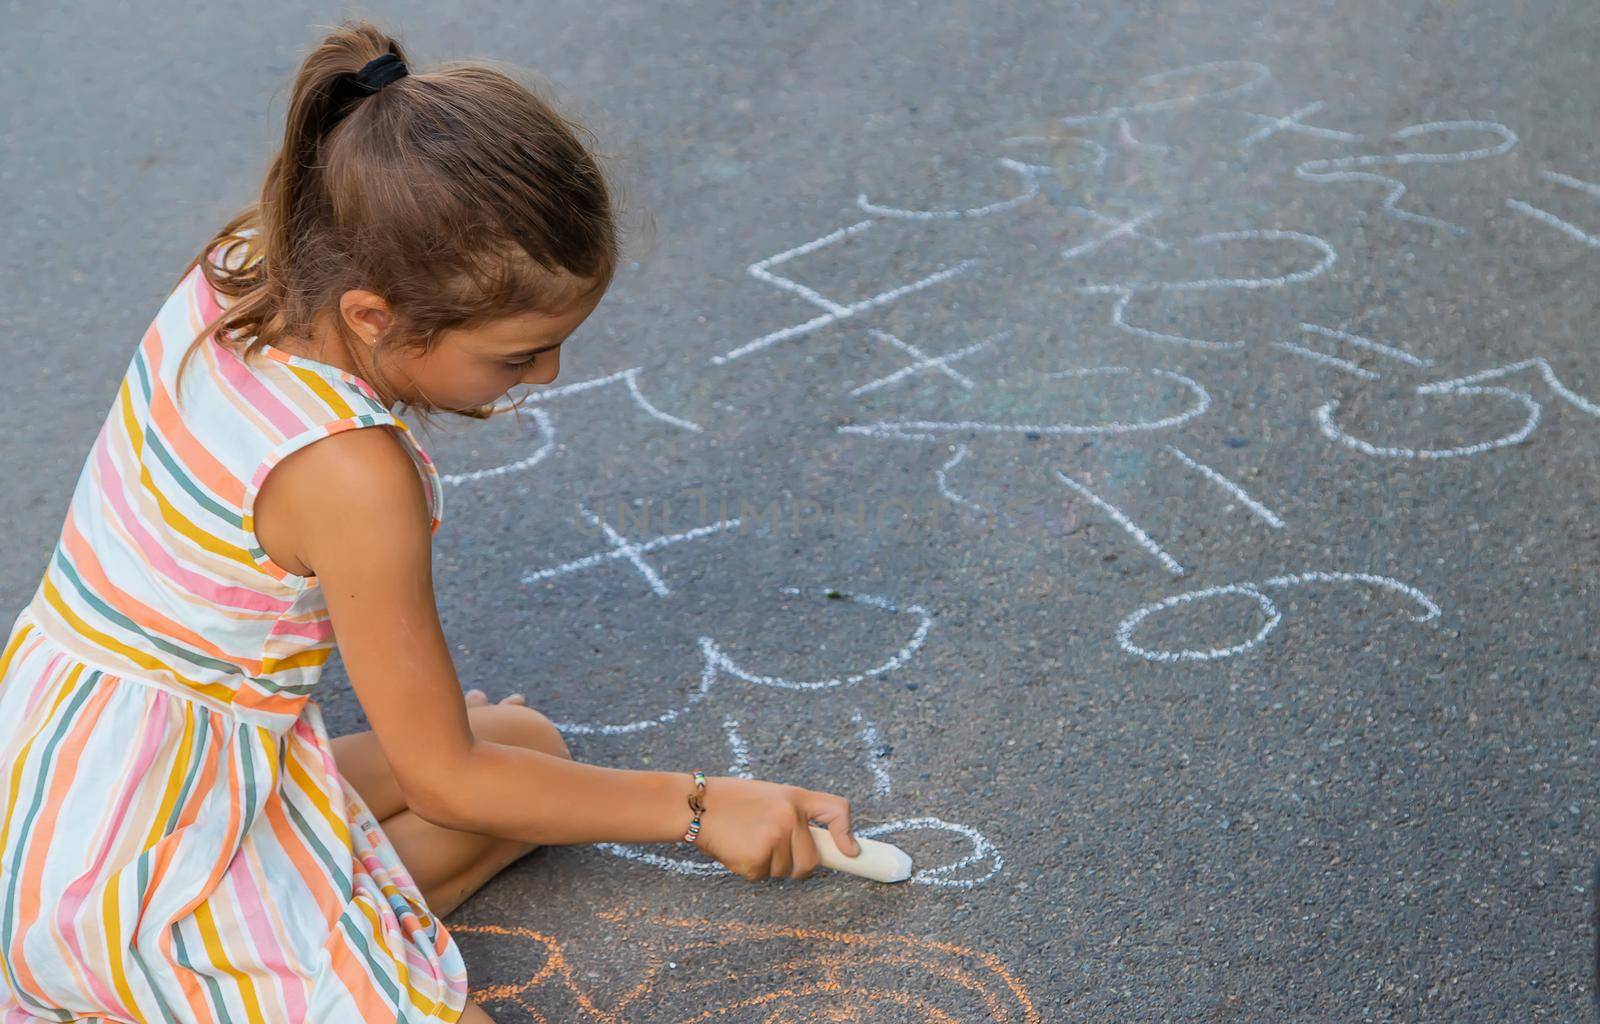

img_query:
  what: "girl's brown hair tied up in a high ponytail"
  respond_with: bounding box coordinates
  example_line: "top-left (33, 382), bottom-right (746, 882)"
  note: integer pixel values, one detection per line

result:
top-left (179, 21), bottom-right (619, 419)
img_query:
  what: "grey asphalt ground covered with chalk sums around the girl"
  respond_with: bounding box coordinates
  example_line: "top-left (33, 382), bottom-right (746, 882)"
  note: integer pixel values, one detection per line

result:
top-left (0, 0), bottom-right (1600, 1024)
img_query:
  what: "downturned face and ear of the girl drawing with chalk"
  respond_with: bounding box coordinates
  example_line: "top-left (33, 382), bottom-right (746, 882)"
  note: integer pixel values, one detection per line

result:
top-left (328, 284), bottom-right (602, 410)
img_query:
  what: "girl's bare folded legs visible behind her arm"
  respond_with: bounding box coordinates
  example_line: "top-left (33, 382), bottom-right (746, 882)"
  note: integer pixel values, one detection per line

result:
top-left (333, 691), bottom-right (571, 915)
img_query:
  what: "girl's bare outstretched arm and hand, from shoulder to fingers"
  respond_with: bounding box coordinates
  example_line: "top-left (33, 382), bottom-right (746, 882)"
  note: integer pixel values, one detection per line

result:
top-left (256, 429), bottom-right (858, 877)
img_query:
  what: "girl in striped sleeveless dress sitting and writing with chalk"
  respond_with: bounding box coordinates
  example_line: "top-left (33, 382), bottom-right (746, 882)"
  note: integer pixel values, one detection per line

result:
top-left (0, 22), bottom-right (859, 1024)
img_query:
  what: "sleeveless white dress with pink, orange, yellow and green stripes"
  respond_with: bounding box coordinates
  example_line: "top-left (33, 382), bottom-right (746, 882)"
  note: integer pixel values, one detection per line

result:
top-left (0, 249), bottom-right (467, 1024)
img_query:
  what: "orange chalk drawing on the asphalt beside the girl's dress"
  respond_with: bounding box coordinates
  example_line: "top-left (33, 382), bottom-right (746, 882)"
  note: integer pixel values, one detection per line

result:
top-left (451, 910), bottom-right (1042, 1024)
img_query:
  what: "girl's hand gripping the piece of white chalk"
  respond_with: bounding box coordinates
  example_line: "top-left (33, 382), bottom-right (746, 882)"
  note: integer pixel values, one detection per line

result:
top-left (696, 776), bottom-right (861, 882)
